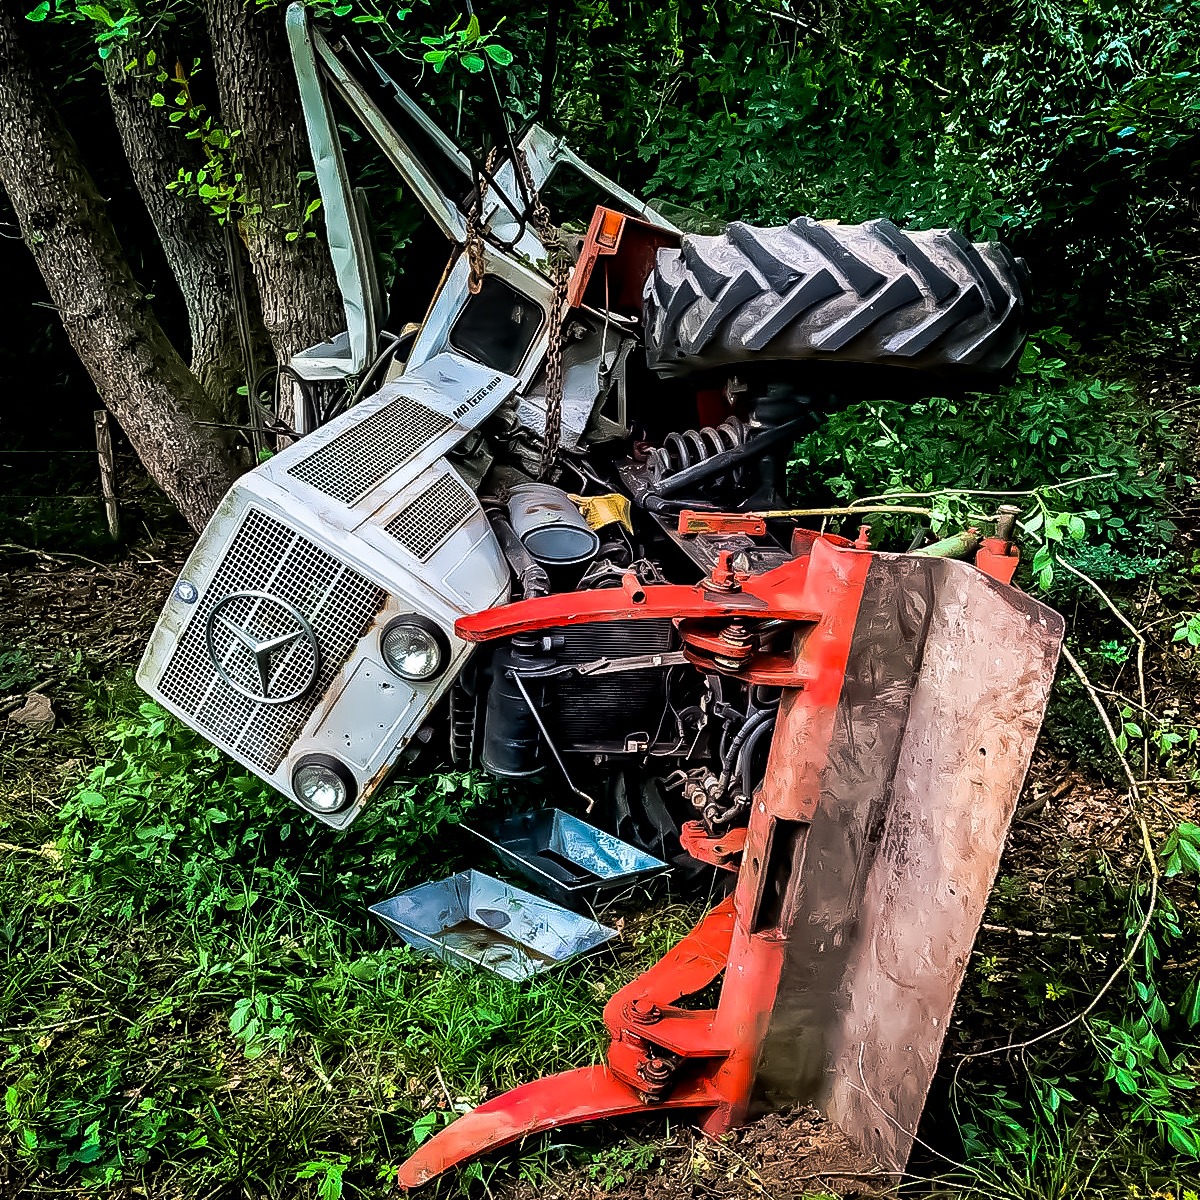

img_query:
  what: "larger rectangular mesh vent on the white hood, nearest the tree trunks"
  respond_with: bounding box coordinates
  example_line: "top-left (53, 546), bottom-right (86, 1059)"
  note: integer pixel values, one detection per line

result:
top-left (288, 396), bottom-right (451, 504)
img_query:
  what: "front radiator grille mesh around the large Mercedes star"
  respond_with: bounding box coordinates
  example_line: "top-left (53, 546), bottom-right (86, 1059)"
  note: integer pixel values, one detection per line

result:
top-left (158, 509), bottom-right (384, 774)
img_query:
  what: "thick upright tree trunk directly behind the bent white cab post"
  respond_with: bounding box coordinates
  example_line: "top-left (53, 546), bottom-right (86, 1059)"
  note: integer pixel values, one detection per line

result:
top-left (204, 0), bottom-right (344, 376)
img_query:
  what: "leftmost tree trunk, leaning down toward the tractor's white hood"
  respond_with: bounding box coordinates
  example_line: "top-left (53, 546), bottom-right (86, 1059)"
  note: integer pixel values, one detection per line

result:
top-left (0, 5), bottom-right (236, 529)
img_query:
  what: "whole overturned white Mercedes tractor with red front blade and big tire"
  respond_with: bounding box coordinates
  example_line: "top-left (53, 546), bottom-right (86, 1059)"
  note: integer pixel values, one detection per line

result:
top-left (138, 5), bottom-right (1062, 1186)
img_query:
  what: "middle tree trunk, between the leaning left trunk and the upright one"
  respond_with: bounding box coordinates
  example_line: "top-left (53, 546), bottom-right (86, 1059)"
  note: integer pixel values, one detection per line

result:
top-left (103, 40), bottom-right (245, 421)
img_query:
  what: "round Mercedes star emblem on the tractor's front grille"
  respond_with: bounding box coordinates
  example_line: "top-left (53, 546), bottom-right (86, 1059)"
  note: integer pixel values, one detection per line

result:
top-left (205, 592), bottom-right (320, 704)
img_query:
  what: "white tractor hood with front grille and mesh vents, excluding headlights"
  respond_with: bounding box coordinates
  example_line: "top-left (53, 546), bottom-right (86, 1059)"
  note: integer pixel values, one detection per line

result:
top-left (138, 354), bottom-right (516, 828)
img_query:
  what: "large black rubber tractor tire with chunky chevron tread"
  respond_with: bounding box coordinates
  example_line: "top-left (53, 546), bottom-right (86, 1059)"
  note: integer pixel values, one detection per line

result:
top-left (643, 217), bottom-right (1028, 376)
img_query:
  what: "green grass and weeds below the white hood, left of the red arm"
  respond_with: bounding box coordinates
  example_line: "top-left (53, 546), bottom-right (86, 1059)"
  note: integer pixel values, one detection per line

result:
top-left (0, 688), bottom-right (694, 1198)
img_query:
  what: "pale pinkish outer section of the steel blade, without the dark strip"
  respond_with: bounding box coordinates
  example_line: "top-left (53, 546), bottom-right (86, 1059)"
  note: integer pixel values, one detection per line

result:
top-left (822, 562), bottom-right (1063, 1170)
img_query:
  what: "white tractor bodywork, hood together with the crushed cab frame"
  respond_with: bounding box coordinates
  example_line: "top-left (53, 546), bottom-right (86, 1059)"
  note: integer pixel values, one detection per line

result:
top-left (138, 4), bottom-right (673, 828)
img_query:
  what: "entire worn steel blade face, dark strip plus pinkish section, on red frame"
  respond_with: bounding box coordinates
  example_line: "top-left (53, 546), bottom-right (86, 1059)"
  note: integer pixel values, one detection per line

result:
top-left (757, 554), bottom-right (1063, 1170)
